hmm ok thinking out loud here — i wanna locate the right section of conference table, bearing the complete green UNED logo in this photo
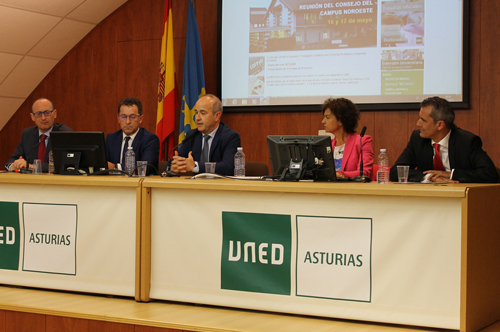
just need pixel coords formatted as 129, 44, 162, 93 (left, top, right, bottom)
140, 177, 500, 331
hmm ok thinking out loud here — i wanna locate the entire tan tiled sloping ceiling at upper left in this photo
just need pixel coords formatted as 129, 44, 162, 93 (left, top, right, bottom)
0, 0, 128, 130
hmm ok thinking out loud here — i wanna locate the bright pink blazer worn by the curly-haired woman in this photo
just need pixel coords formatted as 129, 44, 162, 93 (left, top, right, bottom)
332, 133, 373, 178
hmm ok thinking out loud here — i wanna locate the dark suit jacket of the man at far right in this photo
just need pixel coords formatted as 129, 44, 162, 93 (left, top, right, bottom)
391, 128, 498, 183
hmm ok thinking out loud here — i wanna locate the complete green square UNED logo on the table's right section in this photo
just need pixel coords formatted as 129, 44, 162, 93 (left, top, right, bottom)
221, 212, 292, 295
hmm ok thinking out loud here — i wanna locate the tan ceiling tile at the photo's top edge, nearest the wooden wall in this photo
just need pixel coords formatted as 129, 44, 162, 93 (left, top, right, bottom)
67, 0, 127, 24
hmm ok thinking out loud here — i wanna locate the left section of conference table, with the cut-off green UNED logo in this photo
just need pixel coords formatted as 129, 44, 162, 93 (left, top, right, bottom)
0, 173, 142, 300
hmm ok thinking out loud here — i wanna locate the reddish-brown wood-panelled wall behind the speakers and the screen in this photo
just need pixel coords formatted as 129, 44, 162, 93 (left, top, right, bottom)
0, 0, 500, 171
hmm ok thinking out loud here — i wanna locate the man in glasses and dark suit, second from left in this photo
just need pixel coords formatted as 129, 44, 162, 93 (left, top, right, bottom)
106, 97, 160, 174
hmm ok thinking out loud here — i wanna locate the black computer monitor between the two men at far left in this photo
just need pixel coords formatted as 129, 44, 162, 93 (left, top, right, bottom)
50, 131, 108, 174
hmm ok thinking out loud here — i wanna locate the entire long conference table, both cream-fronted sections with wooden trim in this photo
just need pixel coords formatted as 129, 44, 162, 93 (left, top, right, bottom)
0, 173, 500, 332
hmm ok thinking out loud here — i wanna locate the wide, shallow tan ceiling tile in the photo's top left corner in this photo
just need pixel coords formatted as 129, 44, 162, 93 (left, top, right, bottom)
0, 0, 84, 17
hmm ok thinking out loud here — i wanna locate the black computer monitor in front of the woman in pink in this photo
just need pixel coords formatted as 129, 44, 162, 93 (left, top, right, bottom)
267, 135, 336, 181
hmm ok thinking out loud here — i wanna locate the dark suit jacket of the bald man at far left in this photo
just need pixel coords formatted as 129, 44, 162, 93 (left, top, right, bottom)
5, 123, 73, 173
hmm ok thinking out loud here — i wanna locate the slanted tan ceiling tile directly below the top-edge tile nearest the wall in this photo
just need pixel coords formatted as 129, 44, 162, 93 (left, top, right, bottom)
28, 19, 95, 60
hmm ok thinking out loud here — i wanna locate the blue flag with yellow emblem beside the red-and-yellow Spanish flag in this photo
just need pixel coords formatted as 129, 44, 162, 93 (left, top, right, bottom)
179, 0, 206, 143
